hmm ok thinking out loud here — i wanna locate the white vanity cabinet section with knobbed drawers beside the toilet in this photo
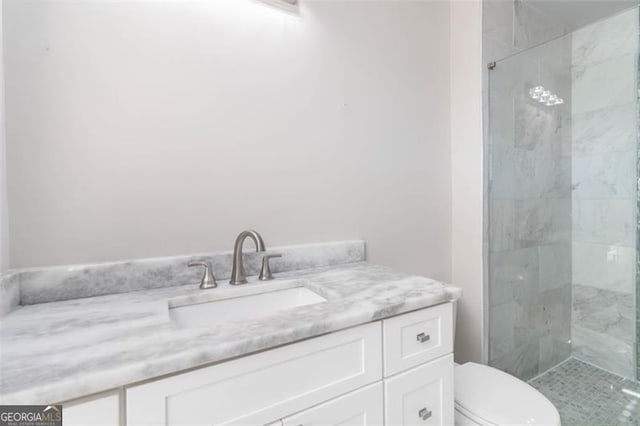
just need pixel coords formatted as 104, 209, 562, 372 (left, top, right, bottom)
125, 303, 454, 426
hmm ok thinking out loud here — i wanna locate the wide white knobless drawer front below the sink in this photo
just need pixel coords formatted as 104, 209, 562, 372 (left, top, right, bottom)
126, 323, 382, 426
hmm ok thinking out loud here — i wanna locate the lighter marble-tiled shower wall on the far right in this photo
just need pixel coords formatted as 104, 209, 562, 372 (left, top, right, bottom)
572, 8, 638, 377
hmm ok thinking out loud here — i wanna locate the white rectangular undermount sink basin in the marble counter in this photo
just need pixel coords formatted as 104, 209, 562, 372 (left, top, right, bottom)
169, 287, 327, 327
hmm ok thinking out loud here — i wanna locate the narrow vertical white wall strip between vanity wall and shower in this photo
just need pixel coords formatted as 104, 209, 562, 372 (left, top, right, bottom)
451, 0, 485, 362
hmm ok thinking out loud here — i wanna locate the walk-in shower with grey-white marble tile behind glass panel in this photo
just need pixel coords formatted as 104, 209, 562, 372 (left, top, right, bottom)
483, 0, 640, 424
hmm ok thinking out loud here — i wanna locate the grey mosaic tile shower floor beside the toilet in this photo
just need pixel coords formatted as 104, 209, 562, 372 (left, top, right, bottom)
529, 358, 640, 426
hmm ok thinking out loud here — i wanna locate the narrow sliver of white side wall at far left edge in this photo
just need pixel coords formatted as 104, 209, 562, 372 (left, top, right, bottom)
0, 2, 9, 273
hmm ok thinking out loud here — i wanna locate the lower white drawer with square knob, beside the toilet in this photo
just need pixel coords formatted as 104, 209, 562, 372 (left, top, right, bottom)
384, 355, 454, 425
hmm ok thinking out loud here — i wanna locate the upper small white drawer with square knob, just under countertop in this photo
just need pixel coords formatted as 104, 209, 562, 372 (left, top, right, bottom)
382, 303, 453, 376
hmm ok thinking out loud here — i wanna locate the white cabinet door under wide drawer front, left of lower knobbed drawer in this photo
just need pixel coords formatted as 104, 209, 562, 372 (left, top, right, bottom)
282, 382, 383, 426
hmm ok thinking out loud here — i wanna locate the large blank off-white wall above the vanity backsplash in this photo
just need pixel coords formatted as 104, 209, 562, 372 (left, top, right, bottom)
5, 0, 451, 280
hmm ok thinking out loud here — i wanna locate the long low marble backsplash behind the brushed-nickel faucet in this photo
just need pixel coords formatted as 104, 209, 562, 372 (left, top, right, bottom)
13, 241, 365, 305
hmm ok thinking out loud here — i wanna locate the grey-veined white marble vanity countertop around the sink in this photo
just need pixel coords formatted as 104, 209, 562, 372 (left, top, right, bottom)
0, 262, 461, 404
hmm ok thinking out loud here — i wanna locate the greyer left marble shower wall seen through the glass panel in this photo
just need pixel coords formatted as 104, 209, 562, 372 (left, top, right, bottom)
488, 31, 572, 379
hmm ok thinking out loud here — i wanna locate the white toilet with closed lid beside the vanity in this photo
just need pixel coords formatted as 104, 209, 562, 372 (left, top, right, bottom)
455, 362, 560, 425
